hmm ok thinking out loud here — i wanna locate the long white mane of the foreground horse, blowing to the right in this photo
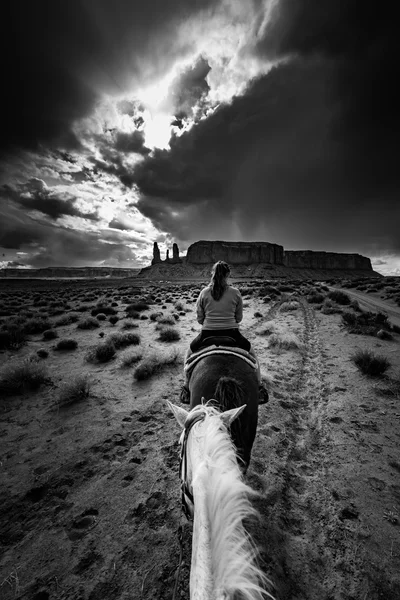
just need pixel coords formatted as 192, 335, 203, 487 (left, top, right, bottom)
189, 405, 273, 600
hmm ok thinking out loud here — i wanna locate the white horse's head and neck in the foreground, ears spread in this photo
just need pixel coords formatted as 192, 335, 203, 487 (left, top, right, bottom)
167, 401, 273, 600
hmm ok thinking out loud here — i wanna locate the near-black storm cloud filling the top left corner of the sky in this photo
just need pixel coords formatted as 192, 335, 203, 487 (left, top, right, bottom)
0, 0, 213, 157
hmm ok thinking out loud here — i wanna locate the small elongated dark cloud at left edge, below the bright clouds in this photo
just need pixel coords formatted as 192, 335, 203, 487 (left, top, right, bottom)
0, 178, 98, 221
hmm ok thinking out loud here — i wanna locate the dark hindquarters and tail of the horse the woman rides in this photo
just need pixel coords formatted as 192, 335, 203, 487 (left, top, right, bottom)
189, 354, 259, 472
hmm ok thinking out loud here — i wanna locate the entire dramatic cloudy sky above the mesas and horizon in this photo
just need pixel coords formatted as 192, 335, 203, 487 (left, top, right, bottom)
0, 0, 400, 275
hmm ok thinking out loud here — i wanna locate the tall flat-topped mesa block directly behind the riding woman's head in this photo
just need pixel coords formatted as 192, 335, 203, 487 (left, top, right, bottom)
186, 240, 284, 265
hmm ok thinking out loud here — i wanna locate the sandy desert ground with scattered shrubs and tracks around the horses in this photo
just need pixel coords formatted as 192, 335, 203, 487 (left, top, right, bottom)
0, 277, 400, 600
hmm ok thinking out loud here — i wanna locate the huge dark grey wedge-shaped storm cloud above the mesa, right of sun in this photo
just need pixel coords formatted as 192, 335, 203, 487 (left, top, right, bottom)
130, 55, 400, 252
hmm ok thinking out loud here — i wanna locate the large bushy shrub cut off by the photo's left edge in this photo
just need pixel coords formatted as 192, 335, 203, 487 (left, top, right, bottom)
0, 357, 48, 394
